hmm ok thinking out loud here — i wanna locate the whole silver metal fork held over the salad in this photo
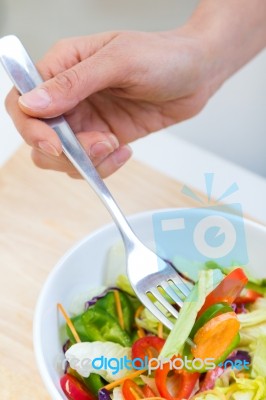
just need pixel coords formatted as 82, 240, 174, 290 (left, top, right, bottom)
0, 35, 190, 330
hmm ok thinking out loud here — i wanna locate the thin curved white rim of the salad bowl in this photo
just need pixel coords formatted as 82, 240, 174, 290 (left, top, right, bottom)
33, 206, 266, 400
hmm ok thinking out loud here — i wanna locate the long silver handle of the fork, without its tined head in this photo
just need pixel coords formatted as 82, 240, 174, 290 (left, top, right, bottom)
0, 35, 138, 246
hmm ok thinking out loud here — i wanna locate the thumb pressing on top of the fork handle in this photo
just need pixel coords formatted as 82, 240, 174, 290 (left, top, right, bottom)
19, 53, 121, 118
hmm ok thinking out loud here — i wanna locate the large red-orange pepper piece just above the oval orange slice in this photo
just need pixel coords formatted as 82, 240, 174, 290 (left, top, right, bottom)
198, 268, 248, 317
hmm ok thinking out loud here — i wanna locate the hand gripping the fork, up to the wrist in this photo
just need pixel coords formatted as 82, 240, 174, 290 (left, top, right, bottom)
6, 29, 213, 177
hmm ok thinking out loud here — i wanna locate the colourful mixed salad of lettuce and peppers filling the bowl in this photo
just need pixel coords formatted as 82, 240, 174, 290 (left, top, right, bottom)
58, 245, 266, 400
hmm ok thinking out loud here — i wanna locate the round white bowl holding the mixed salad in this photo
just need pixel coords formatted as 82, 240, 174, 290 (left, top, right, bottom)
34, 209, 266, 400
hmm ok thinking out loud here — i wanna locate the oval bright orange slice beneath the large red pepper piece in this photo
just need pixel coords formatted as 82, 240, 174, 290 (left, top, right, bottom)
191, 312, 240, 362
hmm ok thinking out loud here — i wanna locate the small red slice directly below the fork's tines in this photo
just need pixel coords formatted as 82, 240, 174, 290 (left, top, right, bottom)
132, 336, 165, 368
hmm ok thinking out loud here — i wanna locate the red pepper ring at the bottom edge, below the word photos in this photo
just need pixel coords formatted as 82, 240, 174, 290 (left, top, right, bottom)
155, 356, 200, 400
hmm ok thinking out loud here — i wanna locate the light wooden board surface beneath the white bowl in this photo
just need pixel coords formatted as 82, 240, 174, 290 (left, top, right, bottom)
0, 145, 206, 400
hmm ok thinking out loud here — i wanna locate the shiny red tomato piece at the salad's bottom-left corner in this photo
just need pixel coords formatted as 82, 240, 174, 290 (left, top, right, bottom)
60, 374, 96, 400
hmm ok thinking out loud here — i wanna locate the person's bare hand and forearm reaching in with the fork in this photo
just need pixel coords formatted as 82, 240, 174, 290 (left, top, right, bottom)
4, 0, 266, 176
